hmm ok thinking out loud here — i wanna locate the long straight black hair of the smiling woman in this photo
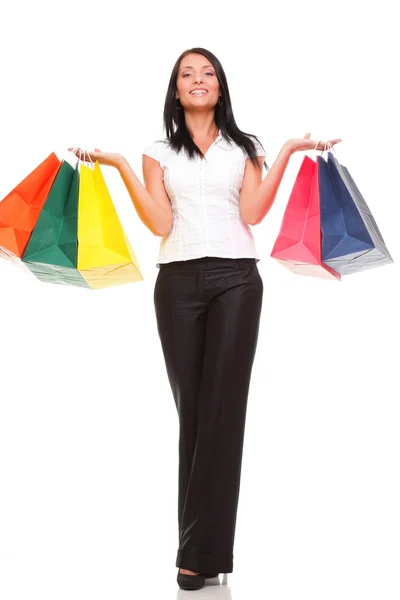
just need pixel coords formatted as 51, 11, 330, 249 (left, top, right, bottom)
163, 48, 269, 171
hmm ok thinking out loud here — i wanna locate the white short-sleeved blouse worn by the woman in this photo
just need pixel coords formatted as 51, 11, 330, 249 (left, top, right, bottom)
142, 130, 265, 267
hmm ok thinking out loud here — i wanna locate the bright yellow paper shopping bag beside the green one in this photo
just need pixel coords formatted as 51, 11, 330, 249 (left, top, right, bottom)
77, 161, 143, 290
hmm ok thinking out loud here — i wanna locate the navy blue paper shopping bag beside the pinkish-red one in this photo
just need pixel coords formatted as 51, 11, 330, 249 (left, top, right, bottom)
317, 152, 393, 275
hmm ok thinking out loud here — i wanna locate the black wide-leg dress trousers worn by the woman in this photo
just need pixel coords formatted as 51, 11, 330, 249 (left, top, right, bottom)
154, 257, 263, 573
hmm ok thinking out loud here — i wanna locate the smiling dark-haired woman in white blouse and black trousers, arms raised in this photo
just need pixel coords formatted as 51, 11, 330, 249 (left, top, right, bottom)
69, 48, 341, 590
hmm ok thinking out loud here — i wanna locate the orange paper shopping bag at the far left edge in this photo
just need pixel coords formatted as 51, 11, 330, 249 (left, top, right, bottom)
0, 152, 61, 262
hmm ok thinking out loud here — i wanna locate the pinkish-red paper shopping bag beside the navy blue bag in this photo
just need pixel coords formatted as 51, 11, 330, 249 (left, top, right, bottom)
271, 156, 341, 280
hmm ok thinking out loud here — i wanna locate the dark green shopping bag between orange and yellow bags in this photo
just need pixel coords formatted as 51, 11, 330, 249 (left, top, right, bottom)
22, 155, 89, 288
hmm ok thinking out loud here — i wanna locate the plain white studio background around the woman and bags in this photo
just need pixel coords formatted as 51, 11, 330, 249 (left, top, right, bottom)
0, 0, 400, 600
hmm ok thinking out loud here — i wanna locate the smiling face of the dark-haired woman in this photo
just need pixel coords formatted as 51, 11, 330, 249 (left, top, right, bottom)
176, 54, 219, 111
